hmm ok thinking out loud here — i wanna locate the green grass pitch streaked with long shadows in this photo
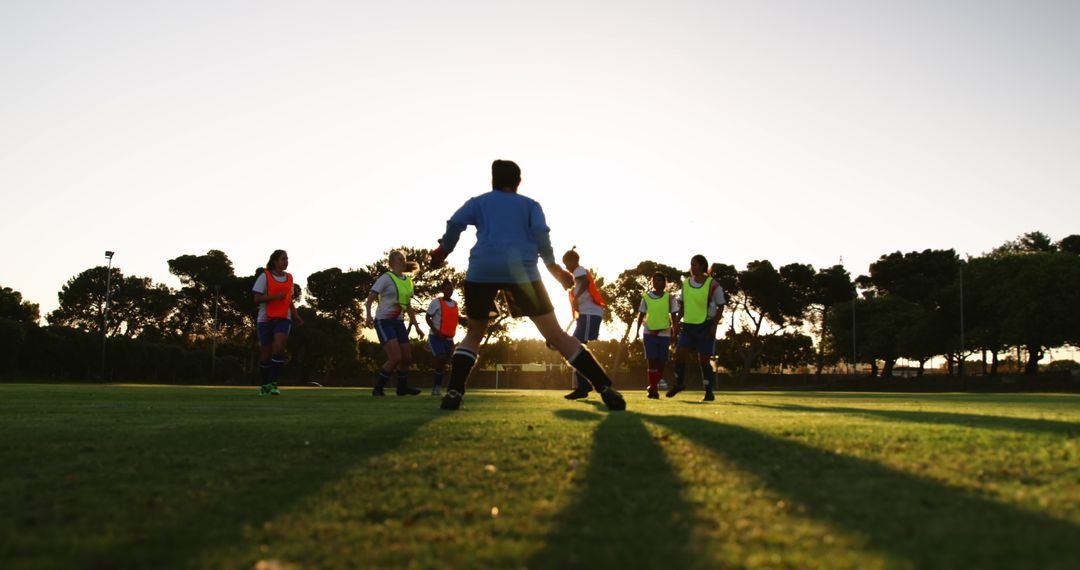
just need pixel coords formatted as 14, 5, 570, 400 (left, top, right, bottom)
0, 384, 1080, 569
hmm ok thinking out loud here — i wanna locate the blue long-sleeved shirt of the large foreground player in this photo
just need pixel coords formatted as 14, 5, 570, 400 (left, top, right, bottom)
438, 190, 555, 283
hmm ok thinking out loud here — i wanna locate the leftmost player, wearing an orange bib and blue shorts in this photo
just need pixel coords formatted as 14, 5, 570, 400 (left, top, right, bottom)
252, 249, 303, 396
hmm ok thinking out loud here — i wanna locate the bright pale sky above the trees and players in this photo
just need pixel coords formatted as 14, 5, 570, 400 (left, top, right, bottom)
0, 0, 1080, 334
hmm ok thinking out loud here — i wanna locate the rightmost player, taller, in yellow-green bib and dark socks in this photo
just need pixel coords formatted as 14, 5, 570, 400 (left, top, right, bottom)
667, 254, 727, 402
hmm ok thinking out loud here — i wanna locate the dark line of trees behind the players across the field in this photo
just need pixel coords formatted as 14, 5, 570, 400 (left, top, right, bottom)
0, 232, 1080, 383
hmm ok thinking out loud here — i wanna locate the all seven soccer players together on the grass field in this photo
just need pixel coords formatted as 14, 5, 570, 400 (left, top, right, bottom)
252, 160, 725, 410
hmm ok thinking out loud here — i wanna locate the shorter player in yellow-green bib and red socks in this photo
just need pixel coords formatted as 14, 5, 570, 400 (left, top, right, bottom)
634, 271, 679, 399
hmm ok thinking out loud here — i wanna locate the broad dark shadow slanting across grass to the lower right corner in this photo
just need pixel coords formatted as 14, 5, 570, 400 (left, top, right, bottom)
645, 416, 1080, 568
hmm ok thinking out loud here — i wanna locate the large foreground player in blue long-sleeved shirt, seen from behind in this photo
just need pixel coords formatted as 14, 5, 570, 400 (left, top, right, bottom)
431, 160, 626, 410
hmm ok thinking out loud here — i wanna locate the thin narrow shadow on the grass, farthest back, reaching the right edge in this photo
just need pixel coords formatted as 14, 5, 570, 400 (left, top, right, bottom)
744, 404, 1080, 437
